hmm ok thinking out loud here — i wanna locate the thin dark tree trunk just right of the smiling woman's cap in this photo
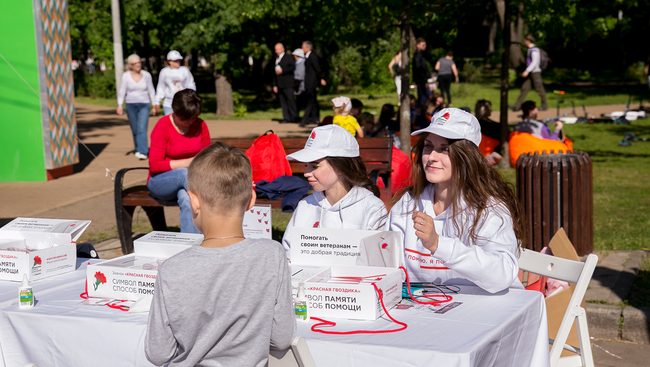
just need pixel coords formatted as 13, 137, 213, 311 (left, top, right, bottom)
497, 2, 511, 168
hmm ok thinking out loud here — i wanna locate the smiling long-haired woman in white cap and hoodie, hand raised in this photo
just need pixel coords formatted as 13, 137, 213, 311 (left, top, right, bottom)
385, 108, 526, 293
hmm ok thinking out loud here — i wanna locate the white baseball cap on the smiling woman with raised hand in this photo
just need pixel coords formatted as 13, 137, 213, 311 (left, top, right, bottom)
411, 108, 481, 147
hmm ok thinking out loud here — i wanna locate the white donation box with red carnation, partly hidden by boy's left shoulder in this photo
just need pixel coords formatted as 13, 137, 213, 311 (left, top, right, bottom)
86, 231, 203, 301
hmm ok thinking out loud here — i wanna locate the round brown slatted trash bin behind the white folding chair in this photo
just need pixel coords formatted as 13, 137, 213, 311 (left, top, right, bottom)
517, 151, 594, 256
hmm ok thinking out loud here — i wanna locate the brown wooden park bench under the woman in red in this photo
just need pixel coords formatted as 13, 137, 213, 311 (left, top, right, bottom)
115, 138, 393, 254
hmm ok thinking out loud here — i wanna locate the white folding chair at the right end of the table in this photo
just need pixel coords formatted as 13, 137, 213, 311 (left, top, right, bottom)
519, 249, 598, 367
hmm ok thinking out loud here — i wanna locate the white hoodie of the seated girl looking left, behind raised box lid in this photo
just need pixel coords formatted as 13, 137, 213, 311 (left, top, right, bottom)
282, 186, 387, 259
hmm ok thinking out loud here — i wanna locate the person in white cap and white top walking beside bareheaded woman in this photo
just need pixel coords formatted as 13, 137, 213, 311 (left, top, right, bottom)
156, 50, 196, 116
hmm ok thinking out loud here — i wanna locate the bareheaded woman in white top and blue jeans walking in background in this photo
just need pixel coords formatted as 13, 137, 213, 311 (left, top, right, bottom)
117, 54, 158, 160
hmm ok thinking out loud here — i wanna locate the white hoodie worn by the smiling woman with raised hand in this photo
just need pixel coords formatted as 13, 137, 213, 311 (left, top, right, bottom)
384, 184, 523, 293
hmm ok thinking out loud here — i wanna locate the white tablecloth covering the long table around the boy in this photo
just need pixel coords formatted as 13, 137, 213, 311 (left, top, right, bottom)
0, 271, 549, 367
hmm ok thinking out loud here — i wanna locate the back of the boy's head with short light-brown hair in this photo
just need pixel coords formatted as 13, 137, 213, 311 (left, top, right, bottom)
187, 141, 253, 215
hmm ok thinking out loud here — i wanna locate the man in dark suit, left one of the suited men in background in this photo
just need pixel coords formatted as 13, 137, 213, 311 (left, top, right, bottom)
273, 43, 298, 123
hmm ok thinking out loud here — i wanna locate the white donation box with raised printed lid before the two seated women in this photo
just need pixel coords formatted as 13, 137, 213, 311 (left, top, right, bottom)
291, 228, 402, 320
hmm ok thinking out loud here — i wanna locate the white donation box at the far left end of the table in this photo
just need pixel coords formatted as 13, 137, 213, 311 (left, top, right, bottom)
0, 218, 90, 281
